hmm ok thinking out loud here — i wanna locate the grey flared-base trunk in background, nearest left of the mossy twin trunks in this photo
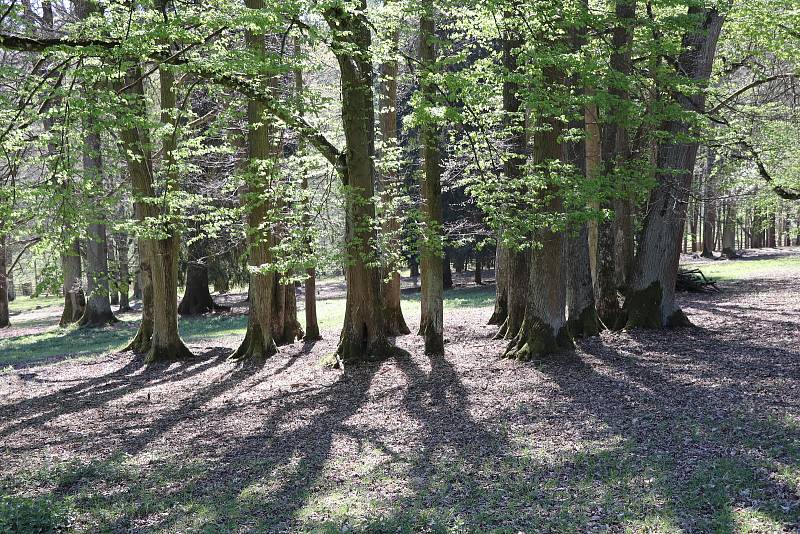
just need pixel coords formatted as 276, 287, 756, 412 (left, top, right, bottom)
78, 117, 117, 327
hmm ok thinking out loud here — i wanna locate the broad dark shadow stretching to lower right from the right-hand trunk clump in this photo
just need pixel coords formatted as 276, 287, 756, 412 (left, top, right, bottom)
540, 339, 800, 532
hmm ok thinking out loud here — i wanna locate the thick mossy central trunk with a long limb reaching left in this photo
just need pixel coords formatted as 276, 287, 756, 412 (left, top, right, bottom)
325, 0, 389, 365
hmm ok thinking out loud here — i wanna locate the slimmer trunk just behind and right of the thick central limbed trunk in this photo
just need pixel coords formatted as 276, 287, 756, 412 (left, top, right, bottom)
379, 6, 411, 336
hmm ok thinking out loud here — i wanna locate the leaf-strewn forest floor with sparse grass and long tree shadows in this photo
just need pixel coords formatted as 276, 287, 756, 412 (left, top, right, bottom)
0, 249, 800, 533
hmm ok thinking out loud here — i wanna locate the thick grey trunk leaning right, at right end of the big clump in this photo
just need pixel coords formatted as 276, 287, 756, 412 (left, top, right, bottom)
625, 6, 723, 328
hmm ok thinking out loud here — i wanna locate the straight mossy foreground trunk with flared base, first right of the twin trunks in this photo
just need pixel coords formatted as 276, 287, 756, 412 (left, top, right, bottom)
232, 0, 278, 361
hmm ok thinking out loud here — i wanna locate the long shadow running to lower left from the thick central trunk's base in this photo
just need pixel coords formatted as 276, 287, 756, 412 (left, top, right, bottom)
134, 354, 380, 532
